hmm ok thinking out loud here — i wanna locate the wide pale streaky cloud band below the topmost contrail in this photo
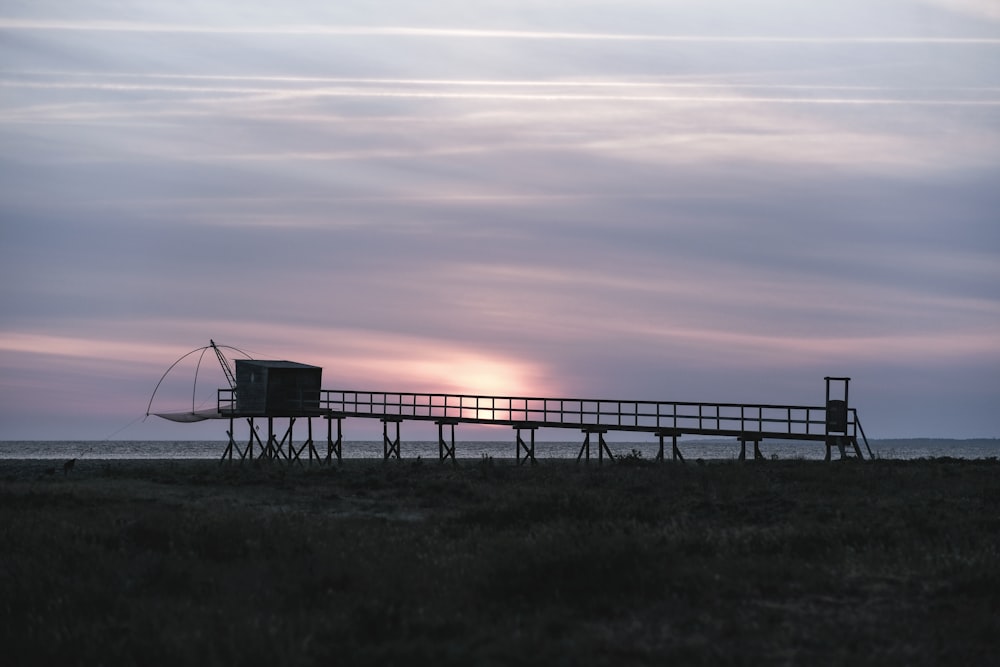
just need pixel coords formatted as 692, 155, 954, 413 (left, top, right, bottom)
0, 69, 1000, 181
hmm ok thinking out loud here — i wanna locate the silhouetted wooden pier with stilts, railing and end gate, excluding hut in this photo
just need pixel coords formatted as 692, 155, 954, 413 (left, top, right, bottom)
205, 377, 871, 464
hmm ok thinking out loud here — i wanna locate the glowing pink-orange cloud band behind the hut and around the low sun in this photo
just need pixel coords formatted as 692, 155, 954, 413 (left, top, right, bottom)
0, 320, 558, 411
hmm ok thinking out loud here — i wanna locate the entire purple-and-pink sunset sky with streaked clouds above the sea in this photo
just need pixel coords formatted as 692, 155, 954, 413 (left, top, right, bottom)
0, 0, 1000, 440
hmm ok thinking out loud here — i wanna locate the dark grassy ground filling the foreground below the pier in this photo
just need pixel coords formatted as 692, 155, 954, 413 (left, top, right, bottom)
0, 459, 1000, 667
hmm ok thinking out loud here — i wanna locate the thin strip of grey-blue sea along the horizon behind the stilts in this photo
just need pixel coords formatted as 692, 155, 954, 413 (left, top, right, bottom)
0, 437, 1000, 460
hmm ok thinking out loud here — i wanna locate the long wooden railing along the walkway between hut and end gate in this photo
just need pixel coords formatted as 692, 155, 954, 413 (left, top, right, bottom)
308, 390, 856, 439
